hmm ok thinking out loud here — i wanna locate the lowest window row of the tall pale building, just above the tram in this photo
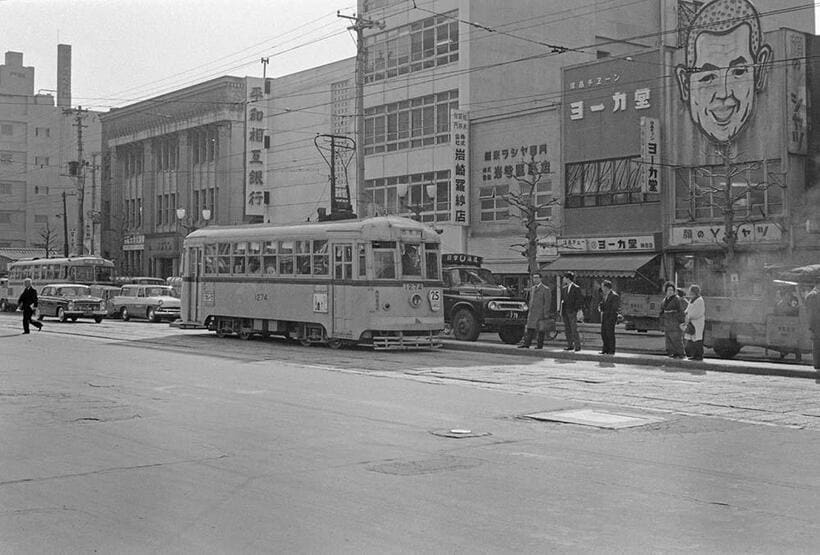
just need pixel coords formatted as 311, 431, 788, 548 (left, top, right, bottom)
365, 170, 450, 222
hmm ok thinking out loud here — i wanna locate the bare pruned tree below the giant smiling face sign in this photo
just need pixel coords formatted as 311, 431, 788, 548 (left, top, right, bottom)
692, 144, 785, 270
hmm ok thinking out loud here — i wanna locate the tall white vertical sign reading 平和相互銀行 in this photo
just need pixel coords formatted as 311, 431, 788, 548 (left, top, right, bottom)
245, 77, 267, 216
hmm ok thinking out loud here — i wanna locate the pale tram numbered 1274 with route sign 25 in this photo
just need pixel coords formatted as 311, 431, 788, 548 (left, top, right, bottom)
180, 216, 444, 349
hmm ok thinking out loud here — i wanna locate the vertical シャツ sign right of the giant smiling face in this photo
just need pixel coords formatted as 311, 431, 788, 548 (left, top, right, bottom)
786, 31, 808, 154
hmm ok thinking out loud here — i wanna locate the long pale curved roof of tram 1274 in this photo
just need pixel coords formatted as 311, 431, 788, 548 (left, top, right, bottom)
186, 216, 438, 241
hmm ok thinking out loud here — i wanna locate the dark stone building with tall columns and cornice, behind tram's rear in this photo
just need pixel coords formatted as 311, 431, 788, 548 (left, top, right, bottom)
101, 77, 247, 277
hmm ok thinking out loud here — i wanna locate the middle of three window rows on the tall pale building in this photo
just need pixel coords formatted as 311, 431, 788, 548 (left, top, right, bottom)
364, 90, 458, 154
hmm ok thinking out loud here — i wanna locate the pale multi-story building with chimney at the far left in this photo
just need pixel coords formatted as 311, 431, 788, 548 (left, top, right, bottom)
0, 45, 101, 254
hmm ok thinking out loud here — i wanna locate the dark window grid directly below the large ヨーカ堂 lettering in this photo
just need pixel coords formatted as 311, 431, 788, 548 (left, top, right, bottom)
565, 157, 660, 208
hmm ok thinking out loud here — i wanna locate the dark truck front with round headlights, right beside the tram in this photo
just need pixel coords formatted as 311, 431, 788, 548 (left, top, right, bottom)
441, 254, 527, 344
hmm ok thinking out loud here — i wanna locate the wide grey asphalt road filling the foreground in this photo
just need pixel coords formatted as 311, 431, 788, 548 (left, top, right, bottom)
0, 315, 820, 553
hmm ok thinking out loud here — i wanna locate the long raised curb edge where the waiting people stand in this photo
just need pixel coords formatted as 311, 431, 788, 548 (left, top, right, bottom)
442, 339, 820, 381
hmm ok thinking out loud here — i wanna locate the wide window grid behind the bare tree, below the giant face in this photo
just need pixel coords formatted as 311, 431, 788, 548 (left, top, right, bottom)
675, 160, 786, 222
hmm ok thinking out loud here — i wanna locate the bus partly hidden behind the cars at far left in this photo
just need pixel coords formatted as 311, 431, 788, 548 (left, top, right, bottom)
3, 256, 114, 310
